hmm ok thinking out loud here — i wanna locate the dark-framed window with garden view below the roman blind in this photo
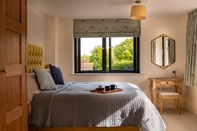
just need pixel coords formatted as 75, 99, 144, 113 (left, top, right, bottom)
74, 37, 139, 73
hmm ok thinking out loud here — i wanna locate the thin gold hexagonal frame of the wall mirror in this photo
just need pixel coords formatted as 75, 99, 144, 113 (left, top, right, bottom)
151, 34, 176, 69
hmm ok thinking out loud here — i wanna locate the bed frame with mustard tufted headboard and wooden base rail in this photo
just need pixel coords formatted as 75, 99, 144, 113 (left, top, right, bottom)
27, 44, 140, 131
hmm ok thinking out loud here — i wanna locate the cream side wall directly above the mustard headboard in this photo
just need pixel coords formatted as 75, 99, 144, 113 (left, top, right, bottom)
27, 5, 45, 67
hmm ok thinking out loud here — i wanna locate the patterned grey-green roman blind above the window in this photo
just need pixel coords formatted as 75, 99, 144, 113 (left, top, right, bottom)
73, 19, 141, 38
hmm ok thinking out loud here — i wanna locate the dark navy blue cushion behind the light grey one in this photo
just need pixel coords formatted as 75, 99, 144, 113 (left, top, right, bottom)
49, 64, 64, 84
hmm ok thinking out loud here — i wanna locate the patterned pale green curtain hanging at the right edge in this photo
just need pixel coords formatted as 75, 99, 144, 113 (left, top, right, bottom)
184, 9, 197, 87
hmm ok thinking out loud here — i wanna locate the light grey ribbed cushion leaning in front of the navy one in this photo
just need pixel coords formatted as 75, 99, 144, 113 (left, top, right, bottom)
33, 69, 57, 90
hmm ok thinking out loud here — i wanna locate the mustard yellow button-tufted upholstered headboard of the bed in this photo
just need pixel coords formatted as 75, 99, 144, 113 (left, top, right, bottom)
27, 44, 43, 73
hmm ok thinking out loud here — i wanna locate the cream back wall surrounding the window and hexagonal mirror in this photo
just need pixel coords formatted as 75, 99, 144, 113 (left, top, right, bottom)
28, 5, 189, 109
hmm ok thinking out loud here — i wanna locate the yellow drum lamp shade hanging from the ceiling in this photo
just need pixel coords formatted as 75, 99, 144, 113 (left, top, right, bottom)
130, 5, 146, 20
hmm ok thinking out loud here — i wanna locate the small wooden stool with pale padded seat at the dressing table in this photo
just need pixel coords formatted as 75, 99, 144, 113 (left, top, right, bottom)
157, 86, 182, 115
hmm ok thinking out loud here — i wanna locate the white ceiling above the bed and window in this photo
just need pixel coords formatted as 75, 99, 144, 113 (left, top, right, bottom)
27, 0, 197, 19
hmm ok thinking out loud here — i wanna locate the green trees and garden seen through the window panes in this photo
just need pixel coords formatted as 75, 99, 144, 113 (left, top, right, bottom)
81, 38, 134, 70
